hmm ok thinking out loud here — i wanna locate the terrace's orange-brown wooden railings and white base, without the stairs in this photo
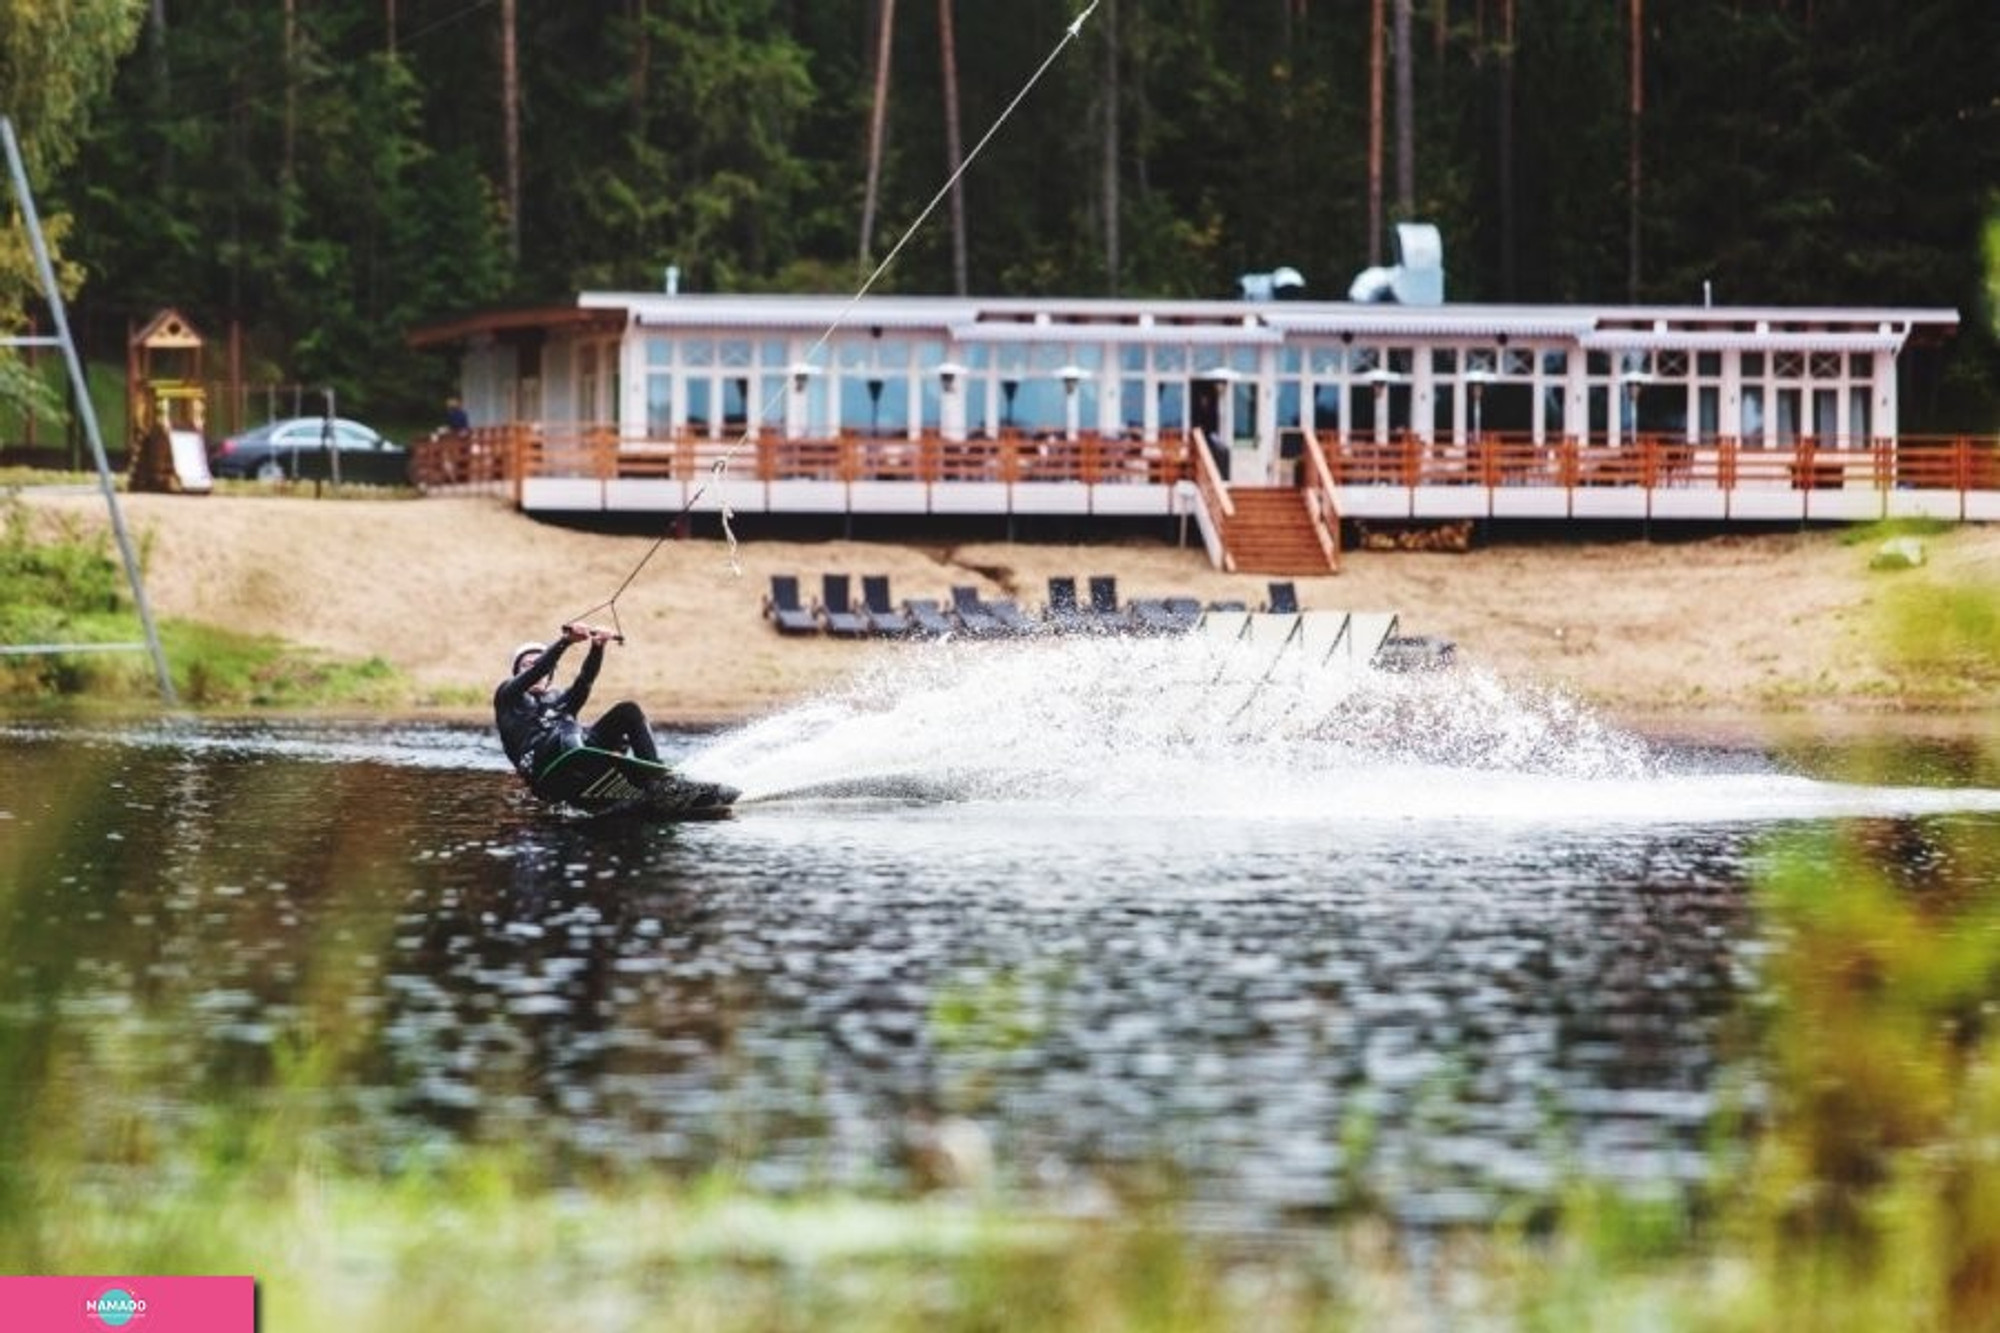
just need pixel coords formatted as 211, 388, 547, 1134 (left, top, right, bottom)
412, 424, 2000, 522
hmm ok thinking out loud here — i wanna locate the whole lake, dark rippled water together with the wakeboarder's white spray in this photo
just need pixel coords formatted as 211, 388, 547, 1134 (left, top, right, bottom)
0, 640, 2000, 1231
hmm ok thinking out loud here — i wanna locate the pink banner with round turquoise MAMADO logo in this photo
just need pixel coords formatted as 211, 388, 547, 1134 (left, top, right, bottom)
0, 1277, 256, 1333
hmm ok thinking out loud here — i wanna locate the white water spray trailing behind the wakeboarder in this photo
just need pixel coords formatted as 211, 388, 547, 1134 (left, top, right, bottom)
682, 638, 2000, 823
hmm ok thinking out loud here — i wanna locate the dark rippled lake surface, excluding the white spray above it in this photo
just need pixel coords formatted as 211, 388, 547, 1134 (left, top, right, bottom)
0, 727, 1990, 1227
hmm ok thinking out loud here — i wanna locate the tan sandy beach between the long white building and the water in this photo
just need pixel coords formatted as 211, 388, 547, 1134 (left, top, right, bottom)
19, 490, 2000, 723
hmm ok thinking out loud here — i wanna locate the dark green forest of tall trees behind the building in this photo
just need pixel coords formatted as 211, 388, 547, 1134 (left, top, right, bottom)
0, 0, 2000, 432
